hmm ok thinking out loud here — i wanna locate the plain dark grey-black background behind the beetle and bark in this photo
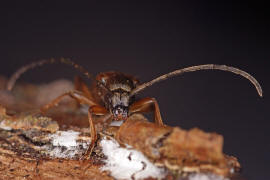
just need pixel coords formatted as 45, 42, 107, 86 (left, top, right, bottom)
0, 1, 270, 179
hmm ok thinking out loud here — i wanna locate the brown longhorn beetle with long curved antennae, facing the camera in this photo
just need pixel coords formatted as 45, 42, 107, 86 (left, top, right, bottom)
7, 58, 262, 157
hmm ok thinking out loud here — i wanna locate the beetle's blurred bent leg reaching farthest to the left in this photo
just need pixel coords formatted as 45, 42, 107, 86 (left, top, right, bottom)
40, 91, 97, 113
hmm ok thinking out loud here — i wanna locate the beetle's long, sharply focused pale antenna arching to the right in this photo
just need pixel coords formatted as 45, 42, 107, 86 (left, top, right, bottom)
130, 64, 263, 97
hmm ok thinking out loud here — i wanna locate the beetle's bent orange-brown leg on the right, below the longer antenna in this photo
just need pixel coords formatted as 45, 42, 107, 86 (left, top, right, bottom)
129, 97, 163, 126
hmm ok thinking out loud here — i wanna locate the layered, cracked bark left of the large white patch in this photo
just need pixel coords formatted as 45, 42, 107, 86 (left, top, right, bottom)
0, 108, 113, 180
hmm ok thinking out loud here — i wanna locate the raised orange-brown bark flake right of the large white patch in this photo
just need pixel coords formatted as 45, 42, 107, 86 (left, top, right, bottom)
116, 114, 240, 176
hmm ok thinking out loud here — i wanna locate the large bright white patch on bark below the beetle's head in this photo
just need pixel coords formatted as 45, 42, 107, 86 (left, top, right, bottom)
100, 139, 166, 179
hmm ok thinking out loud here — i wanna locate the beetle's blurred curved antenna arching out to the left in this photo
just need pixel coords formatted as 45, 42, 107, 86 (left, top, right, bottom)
7, 58, 95, 91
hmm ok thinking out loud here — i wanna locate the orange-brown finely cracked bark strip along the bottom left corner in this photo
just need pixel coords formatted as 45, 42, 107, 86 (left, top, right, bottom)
0, 152, 113, 180
